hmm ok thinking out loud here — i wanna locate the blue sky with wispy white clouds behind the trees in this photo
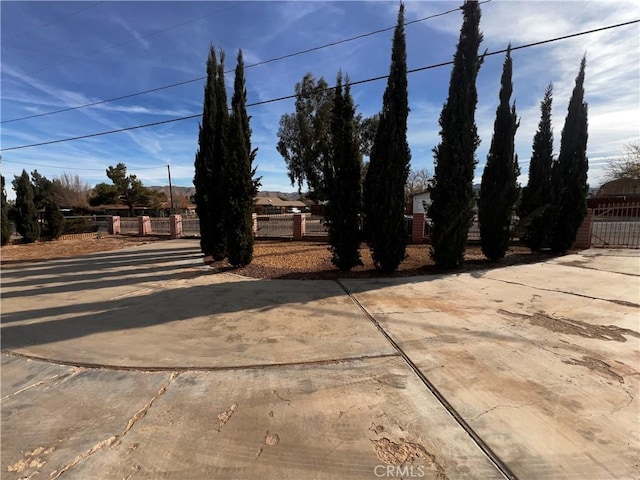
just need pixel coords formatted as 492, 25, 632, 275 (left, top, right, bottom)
0, 0, 640, 199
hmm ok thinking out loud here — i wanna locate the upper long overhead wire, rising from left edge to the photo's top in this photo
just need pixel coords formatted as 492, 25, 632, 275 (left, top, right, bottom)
0, 0, 484, 124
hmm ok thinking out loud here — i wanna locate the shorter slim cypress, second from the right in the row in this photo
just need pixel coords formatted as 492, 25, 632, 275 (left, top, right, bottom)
518, 83, 553, 252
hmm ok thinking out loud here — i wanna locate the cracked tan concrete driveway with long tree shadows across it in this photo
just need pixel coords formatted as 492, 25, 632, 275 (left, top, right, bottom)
0, 240, 640, 480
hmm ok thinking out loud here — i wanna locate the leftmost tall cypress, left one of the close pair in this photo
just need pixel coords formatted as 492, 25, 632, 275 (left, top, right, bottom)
193, 46, 219, 256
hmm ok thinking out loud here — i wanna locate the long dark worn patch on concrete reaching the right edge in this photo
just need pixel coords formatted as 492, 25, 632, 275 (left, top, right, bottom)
498, 309, 640, 342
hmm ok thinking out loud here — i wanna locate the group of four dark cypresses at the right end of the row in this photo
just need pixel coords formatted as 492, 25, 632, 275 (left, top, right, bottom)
429, 1, 588, 268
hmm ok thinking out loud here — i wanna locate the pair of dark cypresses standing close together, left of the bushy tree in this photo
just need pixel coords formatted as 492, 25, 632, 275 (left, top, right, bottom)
193, 46, 259, 266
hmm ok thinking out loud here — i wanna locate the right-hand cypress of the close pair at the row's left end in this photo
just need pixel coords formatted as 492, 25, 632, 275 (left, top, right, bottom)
226, 50, 257, 266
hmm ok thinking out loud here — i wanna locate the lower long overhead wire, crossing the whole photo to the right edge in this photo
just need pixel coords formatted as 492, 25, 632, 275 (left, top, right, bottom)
0, 19, 640, 152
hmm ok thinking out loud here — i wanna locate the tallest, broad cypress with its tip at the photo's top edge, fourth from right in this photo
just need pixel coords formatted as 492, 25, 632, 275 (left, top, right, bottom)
429, 0, 484, 268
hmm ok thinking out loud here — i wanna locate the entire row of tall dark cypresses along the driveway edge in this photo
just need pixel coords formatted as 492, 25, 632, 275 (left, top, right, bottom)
194, 0, 588, 272
